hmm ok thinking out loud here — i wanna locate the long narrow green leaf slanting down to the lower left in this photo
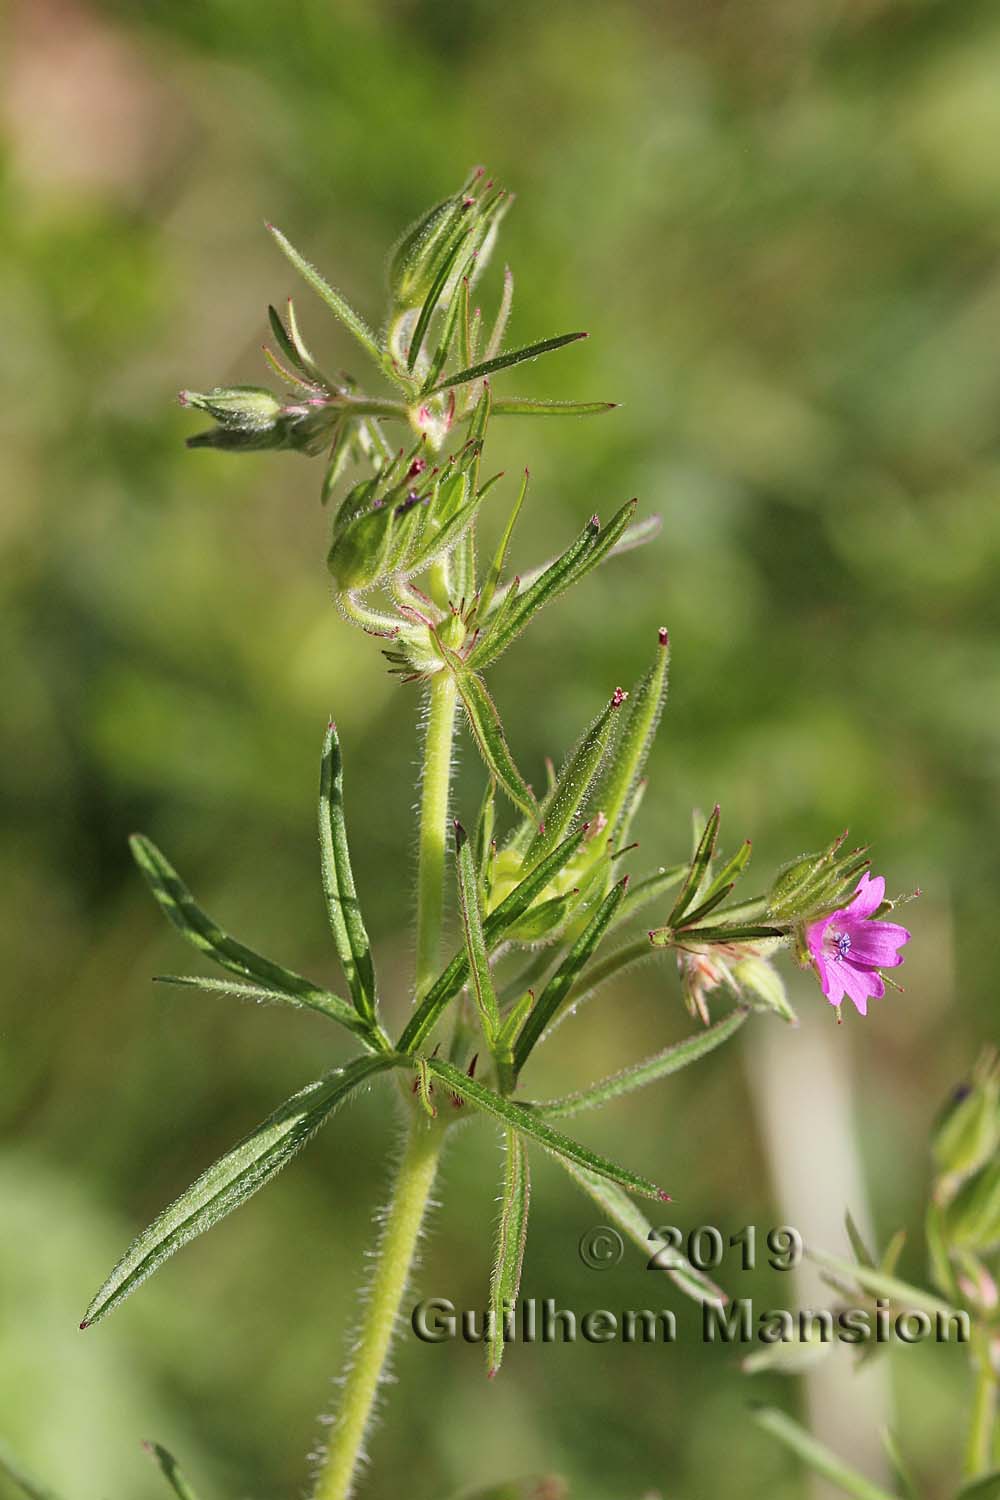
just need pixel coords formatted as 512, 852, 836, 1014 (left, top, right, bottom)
81, 1056, 399, 1328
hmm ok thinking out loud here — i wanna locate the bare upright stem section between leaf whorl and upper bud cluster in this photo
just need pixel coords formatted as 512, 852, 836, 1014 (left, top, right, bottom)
417, 671, 459, 999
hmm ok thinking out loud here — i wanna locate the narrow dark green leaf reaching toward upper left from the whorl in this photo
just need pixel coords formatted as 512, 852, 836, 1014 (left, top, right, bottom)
129, 834, 370, 1044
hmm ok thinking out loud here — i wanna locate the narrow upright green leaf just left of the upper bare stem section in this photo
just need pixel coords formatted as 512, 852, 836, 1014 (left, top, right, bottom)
319, 720, 376, 1023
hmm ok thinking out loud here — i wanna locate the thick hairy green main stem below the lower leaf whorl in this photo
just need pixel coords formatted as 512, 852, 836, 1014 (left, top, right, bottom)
313, 1109, 444, 1500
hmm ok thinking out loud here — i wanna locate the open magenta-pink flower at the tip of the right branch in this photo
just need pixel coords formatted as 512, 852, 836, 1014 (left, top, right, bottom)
805, 870, 910, 1016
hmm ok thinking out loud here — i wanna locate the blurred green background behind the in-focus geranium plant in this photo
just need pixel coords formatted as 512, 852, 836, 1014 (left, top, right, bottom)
0, 0, 1000, 1500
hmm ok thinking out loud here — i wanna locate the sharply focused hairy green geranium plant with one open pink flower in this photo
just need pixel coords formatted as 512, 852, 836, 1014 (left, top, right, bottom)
1, 171, 903, 1500
